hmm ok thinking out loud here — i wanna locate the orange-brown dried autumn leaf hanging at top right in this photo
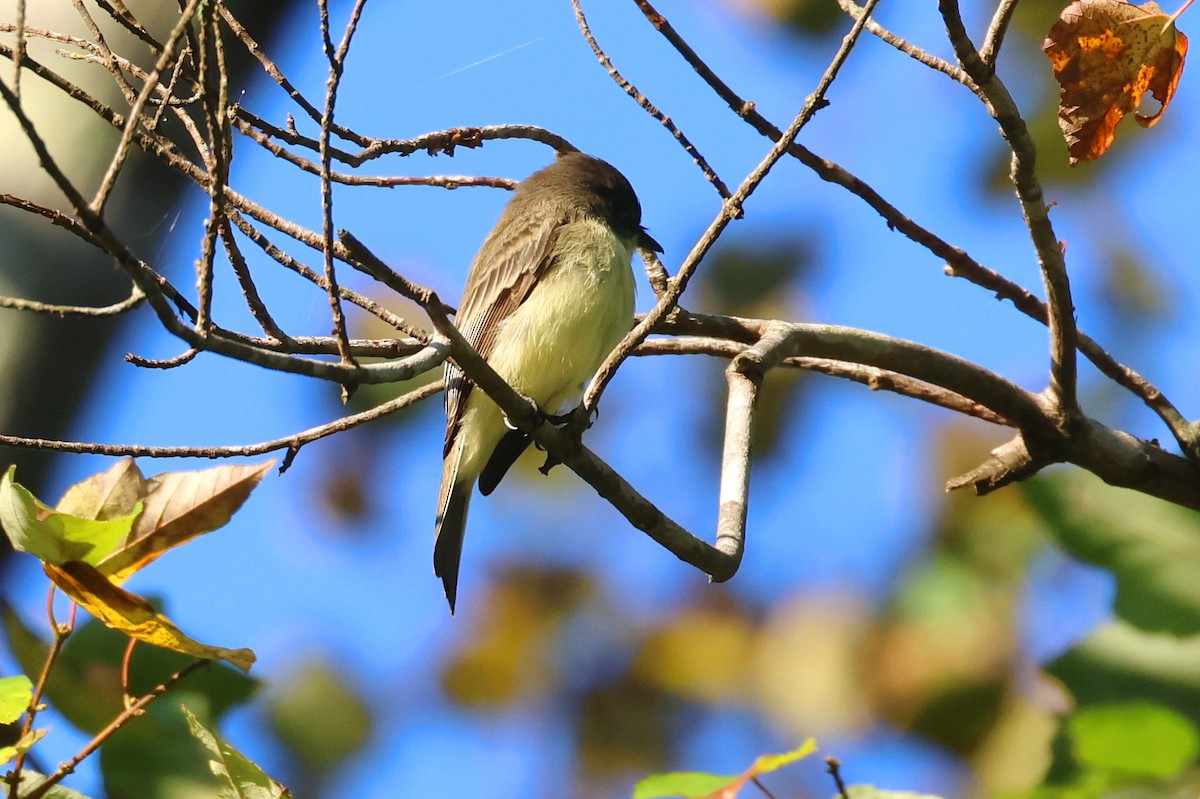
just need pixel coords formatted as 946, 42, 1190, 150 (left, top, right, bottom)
1042, 0, 1188, 166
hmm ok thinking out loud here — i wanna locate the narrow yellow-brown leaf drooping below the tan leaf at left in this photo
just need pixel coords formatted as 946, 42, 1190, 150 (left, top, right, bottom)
43, 560, 254, 669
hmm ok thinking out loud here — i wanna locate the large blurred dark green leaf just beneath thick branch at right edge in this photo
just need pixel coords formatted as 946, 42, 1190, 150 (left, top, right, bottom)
1021, 473, 1200, 636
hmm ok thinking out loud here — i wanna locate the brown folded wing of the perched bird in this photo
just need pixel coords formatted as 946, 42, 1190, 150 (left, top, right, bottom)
443, 208, 562, 457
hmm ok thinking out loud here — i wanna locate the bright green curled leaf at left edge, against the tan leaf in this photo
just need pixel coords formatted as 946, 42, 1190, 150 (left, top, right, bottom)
0, 465, 142, 565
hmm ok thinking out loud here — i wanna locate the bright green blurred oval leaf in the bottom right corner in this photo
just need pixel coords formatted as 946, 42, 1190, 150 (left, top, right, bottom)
1067, 702, 1200, 777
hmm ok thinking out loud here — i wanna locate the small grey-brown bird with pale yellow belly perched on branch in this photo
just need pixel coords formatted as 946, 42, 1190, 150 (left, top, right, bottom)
433, 152, 662, 613
